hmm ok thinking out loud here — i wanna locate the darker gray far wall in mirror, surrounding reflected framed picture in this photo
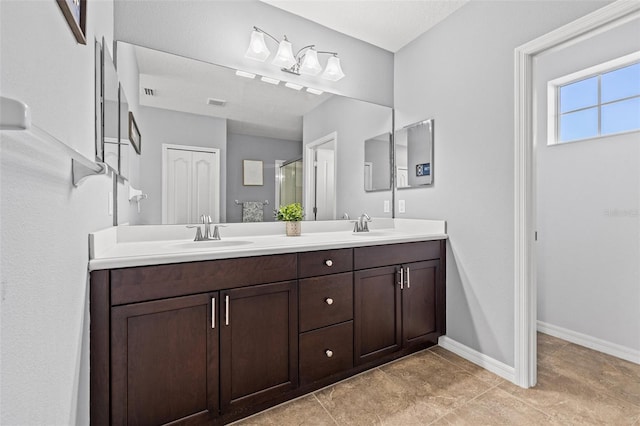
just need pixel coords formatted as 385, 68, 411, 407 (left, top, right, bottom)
227, 133, 302, 222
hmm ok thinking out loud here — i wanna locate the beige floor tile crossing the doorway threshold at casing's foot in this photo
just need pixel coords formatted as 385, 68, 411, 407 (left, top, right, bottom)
499, 366, 640, 425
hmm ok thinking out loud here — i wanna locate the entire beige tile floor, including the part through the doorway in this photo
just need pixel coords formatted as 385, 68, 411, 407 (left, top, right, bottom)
236, 334, 640, 426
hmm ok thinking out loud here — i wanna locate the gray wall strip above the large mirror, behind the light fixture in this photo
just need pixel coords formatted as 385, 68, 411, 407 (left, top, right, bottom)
114, 0, 393, 106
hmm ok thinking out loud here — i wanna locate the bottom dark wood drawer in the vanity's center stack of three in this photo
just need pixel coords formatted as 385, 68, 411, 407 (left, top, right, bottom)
300, 321, 353, 385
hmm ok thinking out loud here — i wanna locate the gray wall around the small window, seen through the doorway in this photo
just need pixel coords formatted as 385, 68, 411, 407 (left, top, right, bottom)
535, 19, 640, 352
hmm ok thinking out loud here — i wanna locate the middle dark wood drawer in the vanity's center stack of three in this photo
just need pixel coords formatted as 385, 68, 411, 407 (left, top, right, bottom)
298, 272, 353, 332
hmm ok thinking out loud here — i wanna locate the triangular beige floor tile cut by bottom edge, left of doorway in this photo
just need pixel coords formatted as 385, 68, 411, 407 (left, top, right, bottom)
434, 388, 560, 426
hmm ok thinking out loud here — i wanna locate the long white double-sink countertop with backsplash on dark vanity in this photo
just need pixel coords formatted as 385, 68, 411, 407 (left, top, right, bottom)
89, 218, 447, 271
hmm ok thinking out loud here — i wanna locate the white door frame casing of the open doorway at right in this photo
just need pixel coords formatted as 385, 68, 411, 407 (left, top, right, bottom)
514, 0, 640, 388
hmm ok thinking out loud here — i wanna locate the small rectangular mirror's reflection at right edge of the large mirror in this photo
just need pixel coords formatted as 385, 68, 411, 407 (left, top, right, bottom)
364, 132, 391, 192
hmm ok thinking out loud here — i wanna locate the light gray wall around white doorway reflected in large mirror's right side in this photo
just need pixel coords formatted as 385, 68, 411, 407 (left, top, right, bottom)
302, 96, 391, 219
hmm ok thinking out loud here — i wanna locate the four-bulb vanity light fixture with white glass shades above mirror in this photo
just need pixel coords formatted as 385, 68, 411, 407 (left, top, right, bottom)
244, 27, 344, 81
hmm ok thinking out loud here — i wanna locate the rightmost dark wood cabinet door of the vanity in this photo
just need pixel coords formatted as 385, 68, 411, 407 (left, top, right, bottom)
402, 260, 440, 347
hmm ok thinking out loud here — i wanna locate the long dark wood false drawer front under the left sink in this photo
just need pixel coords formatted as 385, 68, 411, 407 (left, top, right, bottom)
111, 254, 296, 306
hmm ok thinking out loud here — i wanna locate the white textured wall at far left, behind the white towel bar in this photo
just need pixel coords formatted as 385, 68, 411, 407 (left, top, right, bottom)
0, 1, 113, 425
